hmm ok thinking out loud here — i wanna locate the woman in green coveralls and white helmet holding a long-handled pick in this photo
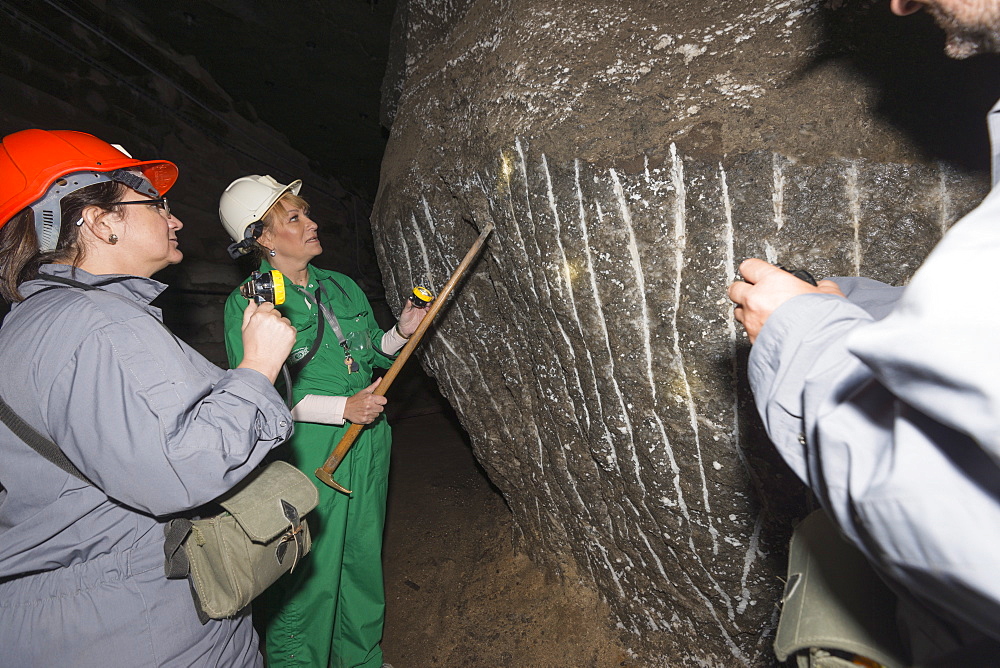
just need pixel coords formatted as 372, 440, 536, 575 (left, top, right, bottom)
219, 176, 426, 668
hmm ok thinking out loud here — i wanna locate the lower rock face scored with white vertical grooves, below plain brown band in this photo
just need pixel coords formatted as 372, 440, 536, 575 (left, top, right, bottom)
376, 141, 981, 661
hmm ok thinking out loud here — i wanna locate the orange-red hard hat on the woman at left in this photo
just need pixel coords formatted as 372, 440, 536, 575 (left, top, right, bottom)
0, 130, 177, 227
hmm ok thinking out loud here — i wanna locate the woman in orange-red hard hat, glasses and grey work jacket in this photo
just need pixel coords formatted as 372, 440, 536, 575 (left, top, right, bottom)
0, 130, 295, 668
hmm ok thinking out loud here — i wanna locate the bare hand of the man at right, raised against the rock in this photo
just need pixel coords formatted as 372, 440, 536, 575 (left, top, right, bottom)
729, 258, 844, 343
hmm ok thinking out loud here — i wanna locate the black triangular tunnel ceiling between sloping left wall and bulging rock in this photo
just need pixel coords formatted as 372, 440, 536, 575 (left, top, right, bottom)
121, 0, 396, 199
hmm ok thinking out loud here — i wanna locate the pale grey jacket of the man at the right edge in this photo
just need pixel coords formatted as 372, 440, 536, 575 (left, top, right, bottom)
749, 98, 1000, 665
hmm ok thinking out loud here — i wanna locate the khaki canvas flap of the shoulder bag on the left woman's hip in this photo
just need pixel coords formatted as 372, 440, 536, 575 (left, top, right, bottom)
216, 461, 319, 543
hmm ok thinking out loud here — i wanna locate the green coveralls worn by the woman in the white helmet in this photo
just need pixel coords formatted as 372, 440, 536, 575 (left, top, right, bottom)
225, 261, 393, 668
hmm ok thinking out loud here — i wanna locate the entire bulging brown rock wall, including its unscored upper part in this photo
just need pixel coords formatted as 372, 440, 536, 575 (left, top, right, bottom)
372, 0, 997, 666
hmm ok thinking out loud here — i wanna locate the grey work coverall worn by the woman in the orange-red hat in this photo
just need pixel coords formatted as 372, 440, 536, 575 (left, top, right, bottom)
0, 265, 292, 668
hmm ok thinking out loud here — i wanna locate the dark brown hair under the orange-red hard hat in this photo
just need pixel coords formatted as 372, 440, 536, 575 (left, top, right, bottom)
0, 181, 127, 302
